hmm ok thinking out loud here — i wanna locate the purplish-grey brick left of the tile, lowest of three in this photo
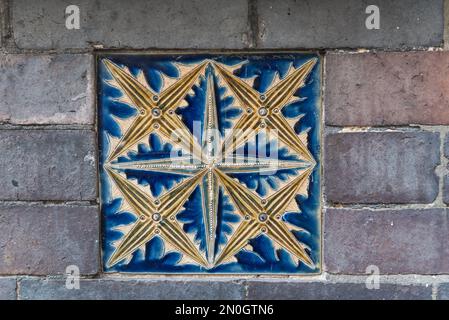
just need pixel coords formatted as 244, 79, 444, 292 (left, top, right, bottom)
0, 204, 100, 275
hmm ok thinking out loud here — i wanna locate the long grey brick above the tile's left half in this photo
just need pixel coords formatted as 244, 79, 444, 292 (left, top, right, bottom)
12, 0, 248, 49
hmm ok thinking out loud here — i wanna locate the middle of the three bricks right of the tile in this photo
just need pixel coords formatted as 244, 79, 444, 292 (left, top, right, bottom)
324, 132, 439, 203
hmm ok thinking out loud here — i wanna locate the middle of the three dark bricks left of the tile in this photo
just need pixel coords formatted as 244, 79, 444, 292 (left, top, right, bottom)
0, 130, 97, 200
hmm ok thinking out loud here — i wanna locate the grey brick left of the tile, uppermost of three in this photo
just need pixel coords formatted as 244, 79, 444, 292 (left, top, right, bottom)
0, 54, 94, 124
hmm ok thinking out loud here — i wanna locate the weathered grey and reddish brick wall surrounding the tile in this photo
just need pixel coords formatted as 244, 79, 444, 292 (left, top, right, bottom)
0, 0, 449, 299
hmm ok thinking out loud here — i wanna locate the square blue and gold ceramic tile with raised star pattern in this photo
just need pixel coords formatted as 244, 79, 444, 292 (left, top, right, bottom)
98, 54, 321, 274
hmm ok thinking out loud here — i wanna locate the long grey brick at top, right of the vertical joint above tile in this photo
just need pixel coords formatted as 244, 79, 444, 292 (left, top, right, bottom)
258, 0, 443, 49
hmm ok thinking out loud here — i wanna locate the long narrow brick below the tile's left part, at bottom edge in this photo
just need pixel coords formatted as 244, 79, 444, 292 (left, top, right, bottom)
19, 279, 244, 300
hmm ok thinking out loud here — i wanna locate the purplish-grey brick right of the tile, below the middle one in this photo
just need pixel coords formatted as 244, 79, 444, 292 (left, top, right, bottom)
324, 209, 449, 274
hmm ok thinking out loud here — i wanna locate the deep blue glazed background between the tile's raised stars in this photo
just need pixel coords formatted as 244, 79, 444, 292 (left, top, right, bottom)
98, 54, 321, 273
